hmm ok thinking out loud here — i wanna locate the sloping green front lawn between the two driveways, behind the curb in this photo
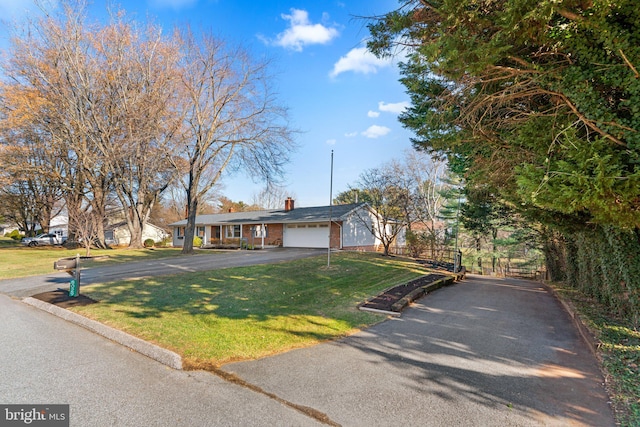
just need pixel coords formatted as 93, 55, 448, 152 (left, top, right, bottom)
73, 253, 440, 369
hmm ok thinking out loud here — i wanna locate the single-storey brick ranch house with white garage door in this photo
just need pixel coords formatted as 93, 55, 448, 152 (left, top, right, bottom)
170, 198, 404, 251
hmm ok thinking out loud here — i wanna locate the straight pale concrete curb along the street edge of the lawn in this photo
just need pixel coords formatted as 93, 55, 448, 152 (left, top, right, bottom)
22, 297, 182, 370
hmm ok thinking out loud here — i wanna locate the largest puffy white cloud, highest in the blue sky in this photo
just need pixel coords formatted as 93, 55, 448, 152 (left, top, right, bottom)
275, 9, 339, 52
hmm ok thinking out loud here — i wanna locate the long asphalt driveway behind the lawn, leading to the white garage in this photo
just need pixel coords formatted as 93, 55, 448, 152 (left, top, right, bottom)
0, 248, 326, 298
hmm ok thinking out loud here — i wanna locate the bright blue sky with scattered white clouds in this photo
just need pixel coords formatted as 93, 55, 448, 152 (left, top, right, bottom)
0, 0, 411, 207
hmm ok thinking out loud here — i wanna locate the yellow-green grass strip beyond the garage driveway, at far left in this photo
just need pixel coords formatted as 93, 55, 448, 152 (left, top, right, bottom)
0, 237, 188, 280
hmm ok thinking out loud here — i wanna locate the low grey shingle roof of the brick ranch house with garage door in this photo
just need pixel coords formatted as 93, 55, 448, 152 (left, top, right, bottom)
169, 203, 365, 227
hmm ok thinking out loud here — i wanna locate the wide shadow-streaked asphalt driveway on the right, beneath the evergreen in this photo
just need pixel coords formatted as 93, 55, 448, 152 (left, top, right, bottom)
223, 276, 615, 427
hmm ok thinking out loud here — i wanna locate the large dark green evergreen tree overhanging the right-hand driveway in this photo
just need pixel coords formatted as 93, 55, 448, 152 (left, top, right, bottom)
369, 0, 640, 228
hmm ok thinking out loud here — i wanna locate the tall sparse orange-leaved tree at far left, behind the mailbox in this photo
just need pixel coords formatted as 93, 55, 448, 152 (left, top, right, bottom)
3, 1, 110, 244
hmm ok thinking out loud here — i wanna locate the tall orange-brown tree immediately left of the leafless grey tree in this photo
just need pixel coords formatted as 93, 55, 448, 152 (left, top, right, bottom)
85, 13, 180, 247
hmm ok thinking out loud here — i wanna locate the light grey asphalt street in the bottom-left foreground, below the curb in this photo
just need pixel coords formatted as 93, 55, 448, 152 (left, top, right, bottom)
0, 295, 321, 427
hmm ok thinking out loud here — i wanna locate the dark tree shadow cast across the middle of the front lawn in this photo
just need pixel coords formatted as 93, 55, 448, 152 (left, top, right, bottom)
85, 266, 382, 326
